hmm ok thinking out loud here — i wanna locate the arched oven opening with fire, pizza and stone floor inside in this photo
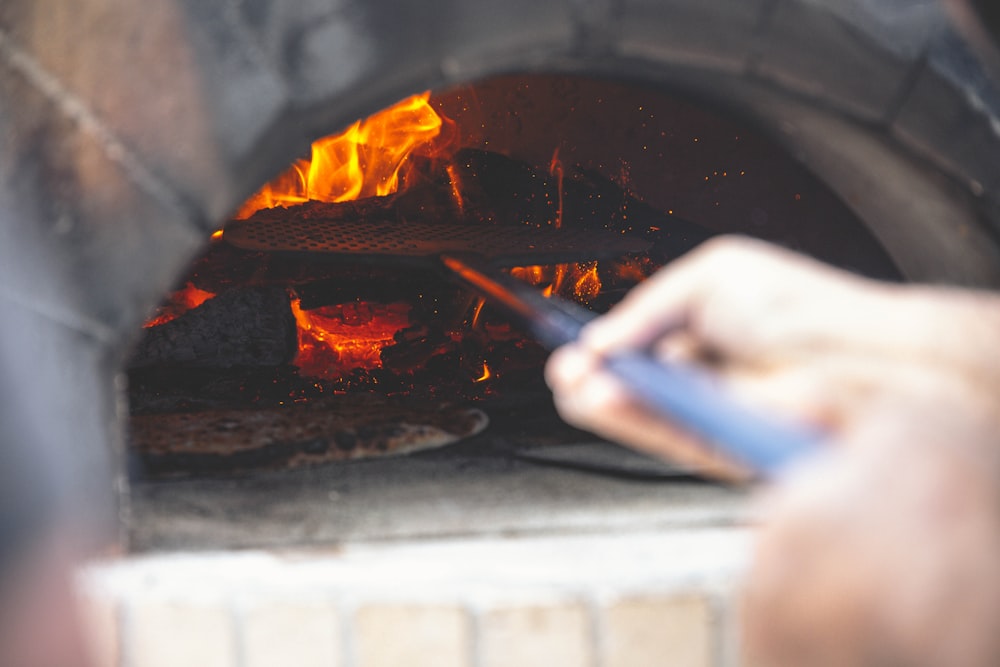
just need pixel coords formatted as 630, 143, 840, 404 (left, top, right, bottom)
128, 74, 900, 549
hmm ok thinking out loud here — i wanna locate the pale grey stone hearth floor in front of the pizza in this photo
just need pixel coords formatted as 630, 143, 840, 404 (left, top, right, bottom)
128, 434, 749, 551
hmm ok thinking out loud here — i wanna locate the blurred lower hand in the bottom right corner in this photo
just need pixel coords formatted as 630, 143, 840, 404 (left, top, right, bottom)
741, 404, 1000, 667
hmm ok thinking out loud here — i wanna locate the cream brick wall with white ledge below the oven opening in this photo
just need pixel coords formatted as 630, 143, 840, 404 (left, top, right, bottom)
80, 529, 747, 667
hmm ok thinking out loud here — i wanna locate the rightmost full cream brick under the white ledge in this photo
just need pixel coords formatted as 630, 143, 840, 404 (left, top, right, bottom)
601, 595, 715, 667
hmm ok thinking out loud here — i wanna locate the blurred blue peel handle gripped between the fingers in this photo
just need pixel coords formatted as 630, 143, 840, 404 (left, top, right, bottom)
606, 353, 824, 477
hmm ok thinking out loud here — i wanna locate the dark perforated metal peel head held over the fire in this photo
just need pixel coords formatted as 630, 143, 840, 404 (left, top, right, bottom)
224, 216, 650, 266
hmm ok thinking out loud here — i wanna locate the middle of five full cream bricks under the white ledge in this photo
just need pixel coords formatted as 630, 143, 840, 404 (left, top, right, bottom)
355, 605, 471, 667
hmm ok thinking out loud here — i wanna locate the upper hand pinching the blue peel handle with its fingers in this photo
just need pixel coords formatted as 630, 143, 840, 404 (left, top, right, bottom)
547, 238, 1000, 478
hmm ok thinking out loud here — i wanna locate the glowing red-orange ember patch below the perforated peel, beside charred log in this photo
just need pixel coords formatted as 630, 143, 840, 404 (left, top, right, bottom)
292, 299, 410, 379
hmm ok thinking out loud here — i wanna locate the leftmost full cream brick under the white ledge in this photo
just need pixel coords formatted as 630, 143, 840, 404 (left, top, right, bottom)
125, 601, 236, 667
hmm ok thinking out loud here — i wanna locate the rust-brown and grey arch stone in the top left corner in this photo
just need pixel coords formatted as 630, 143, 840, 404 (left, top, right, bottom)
0, 0, 286, 221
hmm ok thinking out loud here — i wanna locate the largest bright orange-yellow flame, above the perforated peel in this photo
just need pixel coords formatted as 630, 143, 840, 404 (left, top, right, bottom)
236, 91, 444, 219
